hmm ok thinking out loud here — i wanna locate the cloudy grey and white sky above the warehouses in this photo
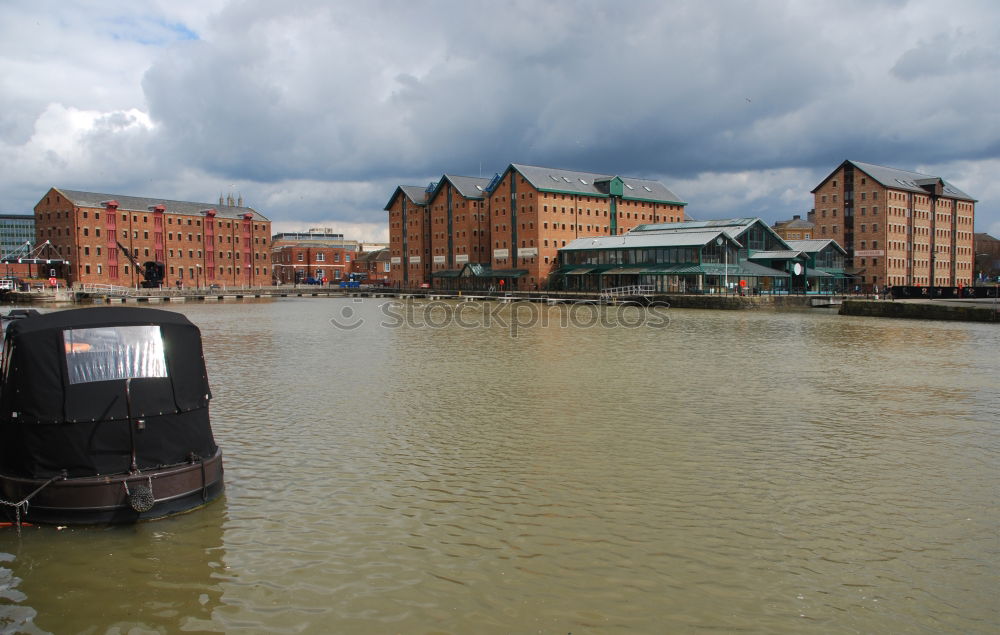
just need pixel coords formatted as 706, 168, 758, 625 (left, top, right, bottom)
0, 0, 1000, 240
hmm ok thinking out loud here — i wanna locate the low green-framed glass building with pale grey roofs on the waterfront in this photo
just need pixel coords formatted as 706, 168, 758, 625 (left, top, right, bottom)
549, 217, 843, 293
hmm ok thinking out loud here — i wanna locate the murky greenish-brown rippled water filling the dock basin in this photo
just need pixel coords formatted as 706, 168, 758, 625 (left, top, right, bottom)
0, 299, 1000, 634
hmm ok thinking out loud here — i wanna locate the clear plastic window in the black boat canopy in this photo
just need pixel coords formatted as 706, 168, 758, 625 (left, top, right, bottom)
63, 326, 167, 384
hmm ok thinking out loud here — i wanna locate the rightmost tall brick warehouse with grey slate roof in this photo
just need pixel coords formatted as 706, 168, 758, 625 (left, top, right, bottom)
809, 160, 976, 289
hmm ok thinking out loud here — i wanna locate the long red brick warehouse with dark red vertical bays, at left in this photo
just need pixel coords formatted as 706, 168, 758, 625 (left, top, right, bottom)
35, 188, 271, 286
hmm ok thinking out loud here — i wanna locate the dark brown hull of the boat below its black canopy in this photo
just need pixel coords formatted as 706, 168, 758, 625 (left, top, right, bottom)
0, 450, 225, 525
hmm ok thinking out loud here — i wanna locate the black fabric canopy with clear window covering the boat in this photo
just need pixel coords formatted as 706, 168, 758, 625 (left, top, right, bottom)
0, 307, 216, 478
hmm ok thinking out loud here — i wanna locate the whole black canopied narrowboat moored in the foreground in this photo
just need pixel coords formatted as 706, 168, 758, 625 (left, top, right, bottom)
0, 307, 224, 525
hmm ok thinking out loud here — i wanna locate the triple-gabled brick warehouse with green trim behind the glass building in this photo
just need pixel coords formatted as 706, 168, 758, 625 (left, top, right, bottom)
385, 163, 687, 290
